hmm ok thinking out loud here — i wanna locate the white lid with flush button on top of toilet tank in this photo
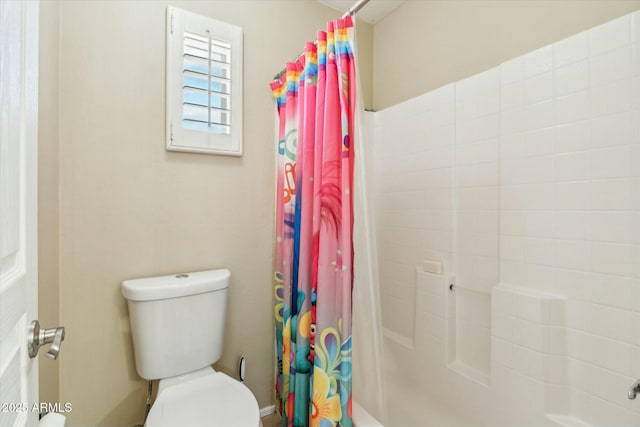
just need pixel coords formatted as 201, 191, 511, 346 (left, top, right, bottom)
122, 268, 231, 301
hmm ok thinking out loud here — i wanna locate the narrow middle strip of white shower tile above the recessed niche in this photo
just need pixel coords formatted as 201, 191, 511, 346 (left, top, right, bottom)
454, 69, 500, 298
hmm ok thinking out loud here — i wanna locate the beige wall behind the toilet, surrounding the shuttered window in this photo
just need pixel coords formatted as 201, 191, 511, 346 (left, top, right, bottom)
39, 0, 373, 427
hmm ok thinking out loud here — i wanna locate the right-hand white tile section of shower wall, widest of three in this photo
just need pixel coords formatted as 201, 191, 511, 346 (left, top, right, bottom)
494, 14, 640, 425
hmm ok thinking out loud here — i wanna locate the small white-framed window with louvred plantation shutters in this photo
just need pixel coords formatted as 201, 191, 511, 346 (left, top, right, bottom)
166, 7, 242, 156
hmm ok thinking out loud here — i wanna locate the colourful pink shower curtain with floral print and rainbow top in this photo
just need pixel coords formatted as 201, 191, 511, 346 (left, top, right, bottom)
271, 17, 356, 427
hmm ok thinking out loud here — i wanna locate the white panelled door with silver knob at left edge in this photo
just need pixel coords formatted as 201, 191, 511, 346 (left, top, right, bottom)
0, 0, 39, 427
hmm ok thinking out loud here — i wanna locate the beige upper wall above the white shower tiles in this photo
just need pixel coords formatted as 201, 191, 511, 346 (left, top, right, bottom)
373, 0, 640, 110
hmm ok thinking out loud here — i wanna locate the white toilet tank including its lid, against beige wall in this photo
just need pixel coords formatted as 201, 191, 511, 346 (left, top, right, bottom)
122, 269, 231, 380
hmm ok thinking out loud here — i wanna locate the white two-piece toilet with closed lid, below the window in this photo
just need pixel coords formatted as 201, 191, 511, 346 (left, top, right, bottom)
122, 269, 261, 427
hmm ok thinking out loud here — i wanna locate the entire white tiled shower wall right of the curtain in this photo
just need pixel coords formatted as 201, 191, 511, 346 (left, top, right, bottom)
373, 12, 640, 425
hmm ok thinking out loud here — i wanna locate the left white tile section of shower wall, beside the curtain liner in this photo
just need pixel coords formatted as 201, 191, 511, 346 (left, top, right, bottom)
373, 85, 455, 341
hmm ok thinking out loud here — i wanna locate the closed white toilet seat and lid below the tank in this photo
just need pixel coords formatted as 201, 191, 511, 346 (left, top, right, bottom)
145, 368, 260, 427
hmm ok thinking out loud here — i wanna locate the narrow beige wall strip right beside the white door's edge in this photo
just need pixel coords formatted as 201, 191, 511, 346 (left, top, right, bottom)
38, 2, 60, 410
